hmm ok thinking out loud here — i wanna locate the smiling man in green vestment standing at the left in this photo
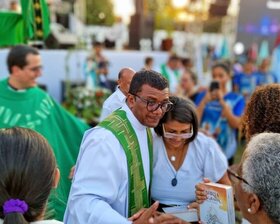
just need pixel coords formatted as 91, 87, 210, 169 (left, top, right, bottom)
0, 45, 89, 220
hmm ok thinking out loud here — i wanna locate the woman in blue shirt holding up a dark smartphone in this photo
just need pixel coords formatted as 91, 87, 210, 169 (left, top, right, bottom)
195, 63, 245, 165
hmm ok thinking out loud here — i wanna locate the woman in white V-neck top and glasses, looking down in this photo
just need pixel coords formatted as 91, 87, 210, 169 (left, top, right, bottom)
151, 96, 230, 212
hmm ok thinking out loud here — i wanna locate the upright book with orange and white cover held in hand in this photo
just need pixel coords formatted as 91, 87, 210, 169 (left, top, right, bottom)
200, 183, 235, 224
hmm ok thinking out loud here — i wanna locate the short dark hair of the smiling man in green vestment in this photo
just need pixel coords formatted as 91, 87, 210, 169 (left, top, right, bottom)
7, 45, 39, 73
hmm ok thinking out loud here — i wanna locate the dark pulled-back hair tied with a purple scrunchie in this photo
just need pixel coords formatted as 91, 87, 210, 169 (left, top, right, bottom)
0, 127, 56, 224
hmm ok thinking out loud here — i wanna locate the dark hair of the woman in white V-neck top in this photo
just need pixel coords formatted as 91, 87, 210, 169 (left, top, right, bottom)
154, 96, 198, 142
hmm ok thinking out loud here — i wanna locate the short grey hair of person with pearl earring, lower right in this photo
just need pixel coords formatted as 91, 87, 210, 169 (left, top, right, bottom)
241, 133, 280, 223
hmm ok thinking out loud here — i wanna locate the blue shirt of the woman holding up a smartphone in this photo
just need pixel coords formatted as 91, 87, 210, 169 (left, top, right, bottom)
195, 92, 245, 159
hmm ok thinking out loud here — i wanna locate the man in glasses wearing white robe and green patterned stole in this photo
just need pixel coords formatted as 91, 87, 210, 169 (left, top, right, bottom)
64, 70, 182, 224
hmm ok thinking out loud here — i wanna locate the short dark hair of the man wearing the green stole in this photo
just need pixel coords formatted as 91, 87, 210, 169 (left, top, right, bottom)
129, 70, 168, 94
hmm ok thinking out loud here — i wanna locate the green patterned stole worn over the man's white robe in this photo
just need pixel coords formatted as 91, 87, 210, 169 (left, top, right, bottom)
98, 110, 153, 217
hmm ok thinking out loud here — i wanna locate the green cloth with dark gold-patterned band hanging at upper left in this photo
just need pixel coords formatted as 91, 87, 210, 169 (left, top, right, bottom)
21, 0, 50, 40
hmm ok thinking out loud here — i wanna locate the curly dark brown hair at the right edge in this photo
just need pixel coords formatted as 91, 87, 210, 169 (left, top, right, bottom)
242, 84, 280, 141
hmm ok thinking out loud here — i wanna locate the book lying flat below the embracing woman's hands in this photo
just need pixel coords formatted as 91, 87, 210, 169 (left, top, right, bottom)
162, 205, 198, 222
